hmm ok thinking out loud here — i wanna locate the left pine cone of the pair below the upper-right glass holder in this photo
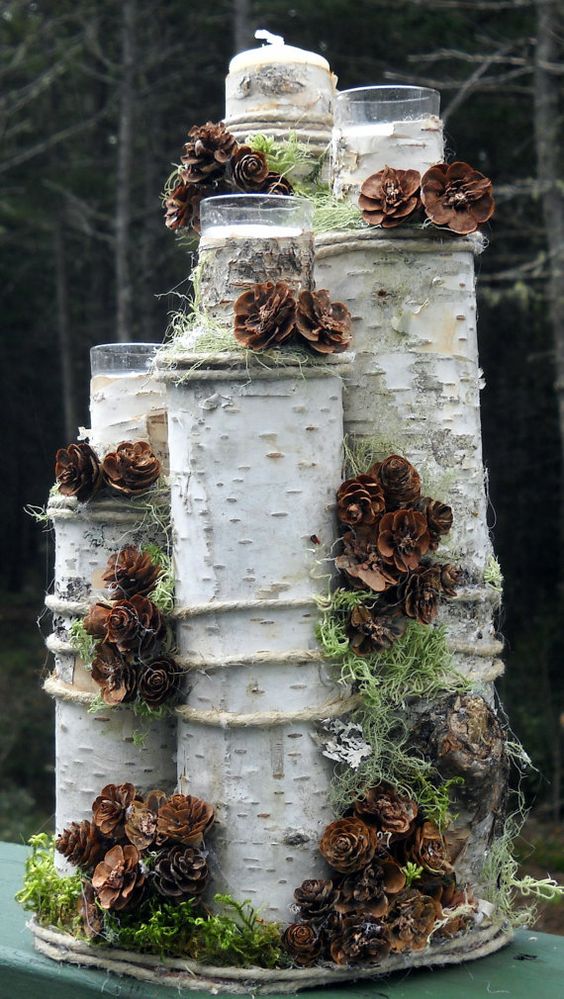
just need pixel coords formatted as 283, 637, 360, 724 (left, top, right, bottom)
358, 166, 421, 229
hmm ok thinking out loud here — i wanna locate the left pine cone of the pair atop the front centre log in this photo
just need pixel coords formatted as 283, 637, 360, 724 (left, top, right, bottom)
233, 281, 296, 350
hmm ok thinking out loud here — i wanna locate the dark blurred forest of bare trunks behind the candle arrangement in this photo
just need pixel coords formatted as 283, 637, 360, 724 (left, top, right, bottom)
0, 0, 564, 926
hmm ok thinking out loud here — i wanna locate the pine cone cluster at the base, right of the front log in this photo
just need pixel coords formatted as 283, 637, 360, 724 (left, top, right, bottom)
282, 784, 477, 967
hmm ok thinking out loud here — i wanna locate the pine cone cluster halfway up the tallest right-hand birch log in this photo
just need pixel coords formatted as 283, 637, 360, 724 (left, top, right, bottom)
335, 454, 460, 656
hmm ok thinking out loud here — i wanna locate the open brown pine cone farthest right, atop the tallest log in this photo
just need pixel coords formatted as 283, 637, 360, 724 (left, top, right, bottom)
421, 161, 495, 235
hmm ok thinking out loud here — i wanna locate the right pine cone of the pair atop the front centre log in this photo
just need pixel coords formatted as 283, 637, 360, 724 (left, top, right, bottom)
296, 288, 352, 354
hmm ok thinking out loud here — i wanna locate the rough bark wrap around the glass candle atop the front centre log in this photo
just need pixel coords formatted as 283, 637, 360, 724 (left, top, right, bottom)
199, 233, 313, 325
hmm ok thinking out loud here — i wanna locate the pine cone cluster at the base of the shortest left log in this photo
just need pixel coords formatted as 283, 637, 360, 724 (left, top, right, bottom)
56, 784, 214, 937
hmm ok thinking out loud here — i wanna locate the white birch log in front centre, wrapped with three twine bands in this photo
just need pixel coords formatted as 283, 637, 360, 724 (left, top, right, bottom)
158, 355, 347, 921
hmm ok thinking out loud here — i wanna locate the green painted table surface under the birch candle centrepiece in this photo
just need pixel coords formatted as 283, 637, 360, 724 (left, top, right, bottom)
0, 843, 564, 999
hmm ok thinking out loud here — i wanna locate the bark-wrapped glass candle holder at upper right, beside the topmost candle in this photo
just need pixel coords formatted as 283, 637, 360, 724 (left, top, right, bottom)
332, 86, 444, 201
